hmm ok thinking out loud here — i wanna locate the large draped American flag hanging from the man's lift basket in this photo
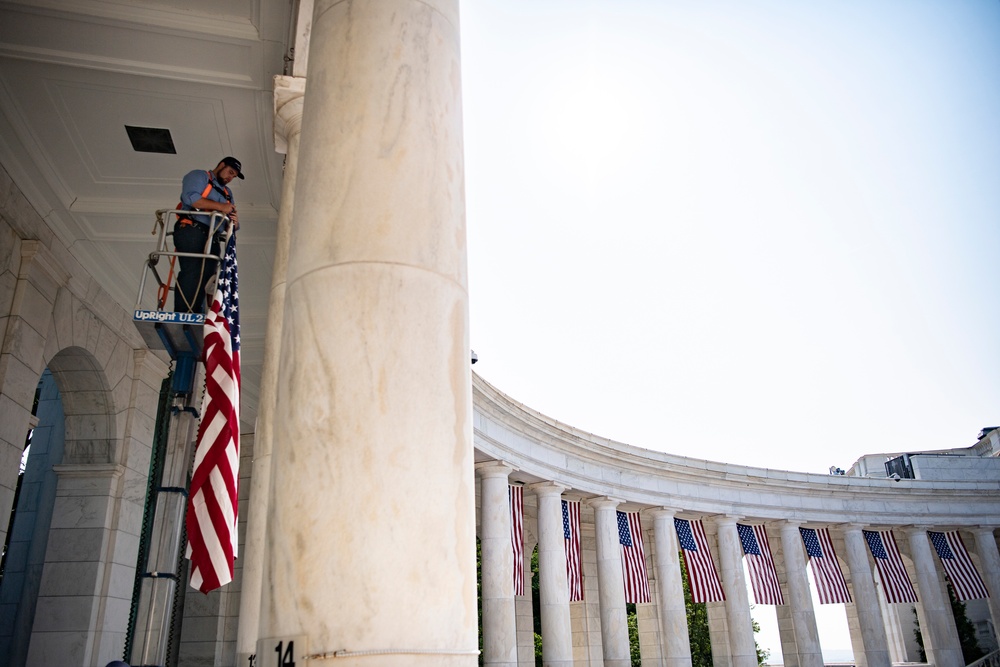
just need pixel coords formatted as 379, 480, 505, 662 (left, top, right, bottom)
187, 234, 240, 593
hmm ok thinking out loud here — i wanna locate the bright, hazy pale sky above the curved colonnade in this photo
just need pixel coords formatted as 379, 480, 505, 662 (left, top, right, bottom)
462, 0, 1000, 650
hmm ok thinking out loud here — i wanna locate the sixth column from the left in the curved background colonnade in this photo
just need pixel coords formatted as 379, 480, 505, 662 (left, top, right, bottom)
780, 521, 823, 667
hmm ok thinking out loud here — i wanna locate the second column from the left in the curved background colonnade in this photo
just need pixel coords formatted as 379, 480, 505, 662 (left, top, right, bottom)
529, 482, 573, 667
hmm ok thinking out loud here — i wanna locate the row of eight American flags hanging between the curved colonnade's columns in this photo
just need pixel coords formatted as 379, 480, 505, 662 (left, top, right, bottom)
510, 485, 989, 605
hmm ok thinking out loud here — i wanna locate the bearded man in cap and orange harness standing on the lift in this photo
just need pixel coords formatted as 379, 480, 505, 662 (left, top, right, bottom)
174, 157, 243, 313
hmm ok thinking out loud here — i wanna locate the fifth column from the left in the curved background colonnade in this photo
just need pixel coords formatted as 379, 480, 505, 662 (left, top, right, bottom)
715, 514, 757, 667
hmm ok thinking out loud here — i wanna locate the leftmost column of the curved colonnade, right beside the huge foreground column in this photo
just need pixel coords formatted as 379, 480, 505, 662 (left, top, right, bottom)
476, 461, 517, 667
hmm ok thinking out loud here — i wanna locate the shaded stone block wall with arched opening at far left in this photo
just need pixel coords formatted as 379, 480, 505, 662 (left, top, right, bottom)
0, 163, 167, 665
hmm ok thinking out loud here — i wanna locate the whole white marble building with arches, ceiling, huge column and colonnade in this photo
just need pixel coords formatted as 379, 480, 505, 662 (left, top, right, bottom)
0, 0, 1000, 667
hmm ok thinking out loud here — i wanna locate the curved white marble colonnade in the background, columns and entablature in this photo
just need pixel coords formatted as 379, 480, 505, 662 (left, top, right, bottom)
473, 375, 1000, 667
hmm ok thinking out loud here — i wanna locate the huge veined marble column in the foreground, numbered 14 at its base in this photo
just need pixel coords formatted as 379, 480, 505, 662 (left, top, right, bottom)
258, 0, 478, 667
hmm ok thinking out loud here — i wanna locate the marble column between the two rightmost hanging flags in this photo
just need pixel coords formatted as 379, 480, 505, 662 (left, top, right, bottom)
905, 526, 965, 667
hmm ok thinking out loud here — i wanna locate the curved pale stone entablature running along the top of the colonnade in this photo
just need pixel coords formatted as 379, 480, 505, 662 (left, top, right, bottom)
473, 374, 1000, 527
